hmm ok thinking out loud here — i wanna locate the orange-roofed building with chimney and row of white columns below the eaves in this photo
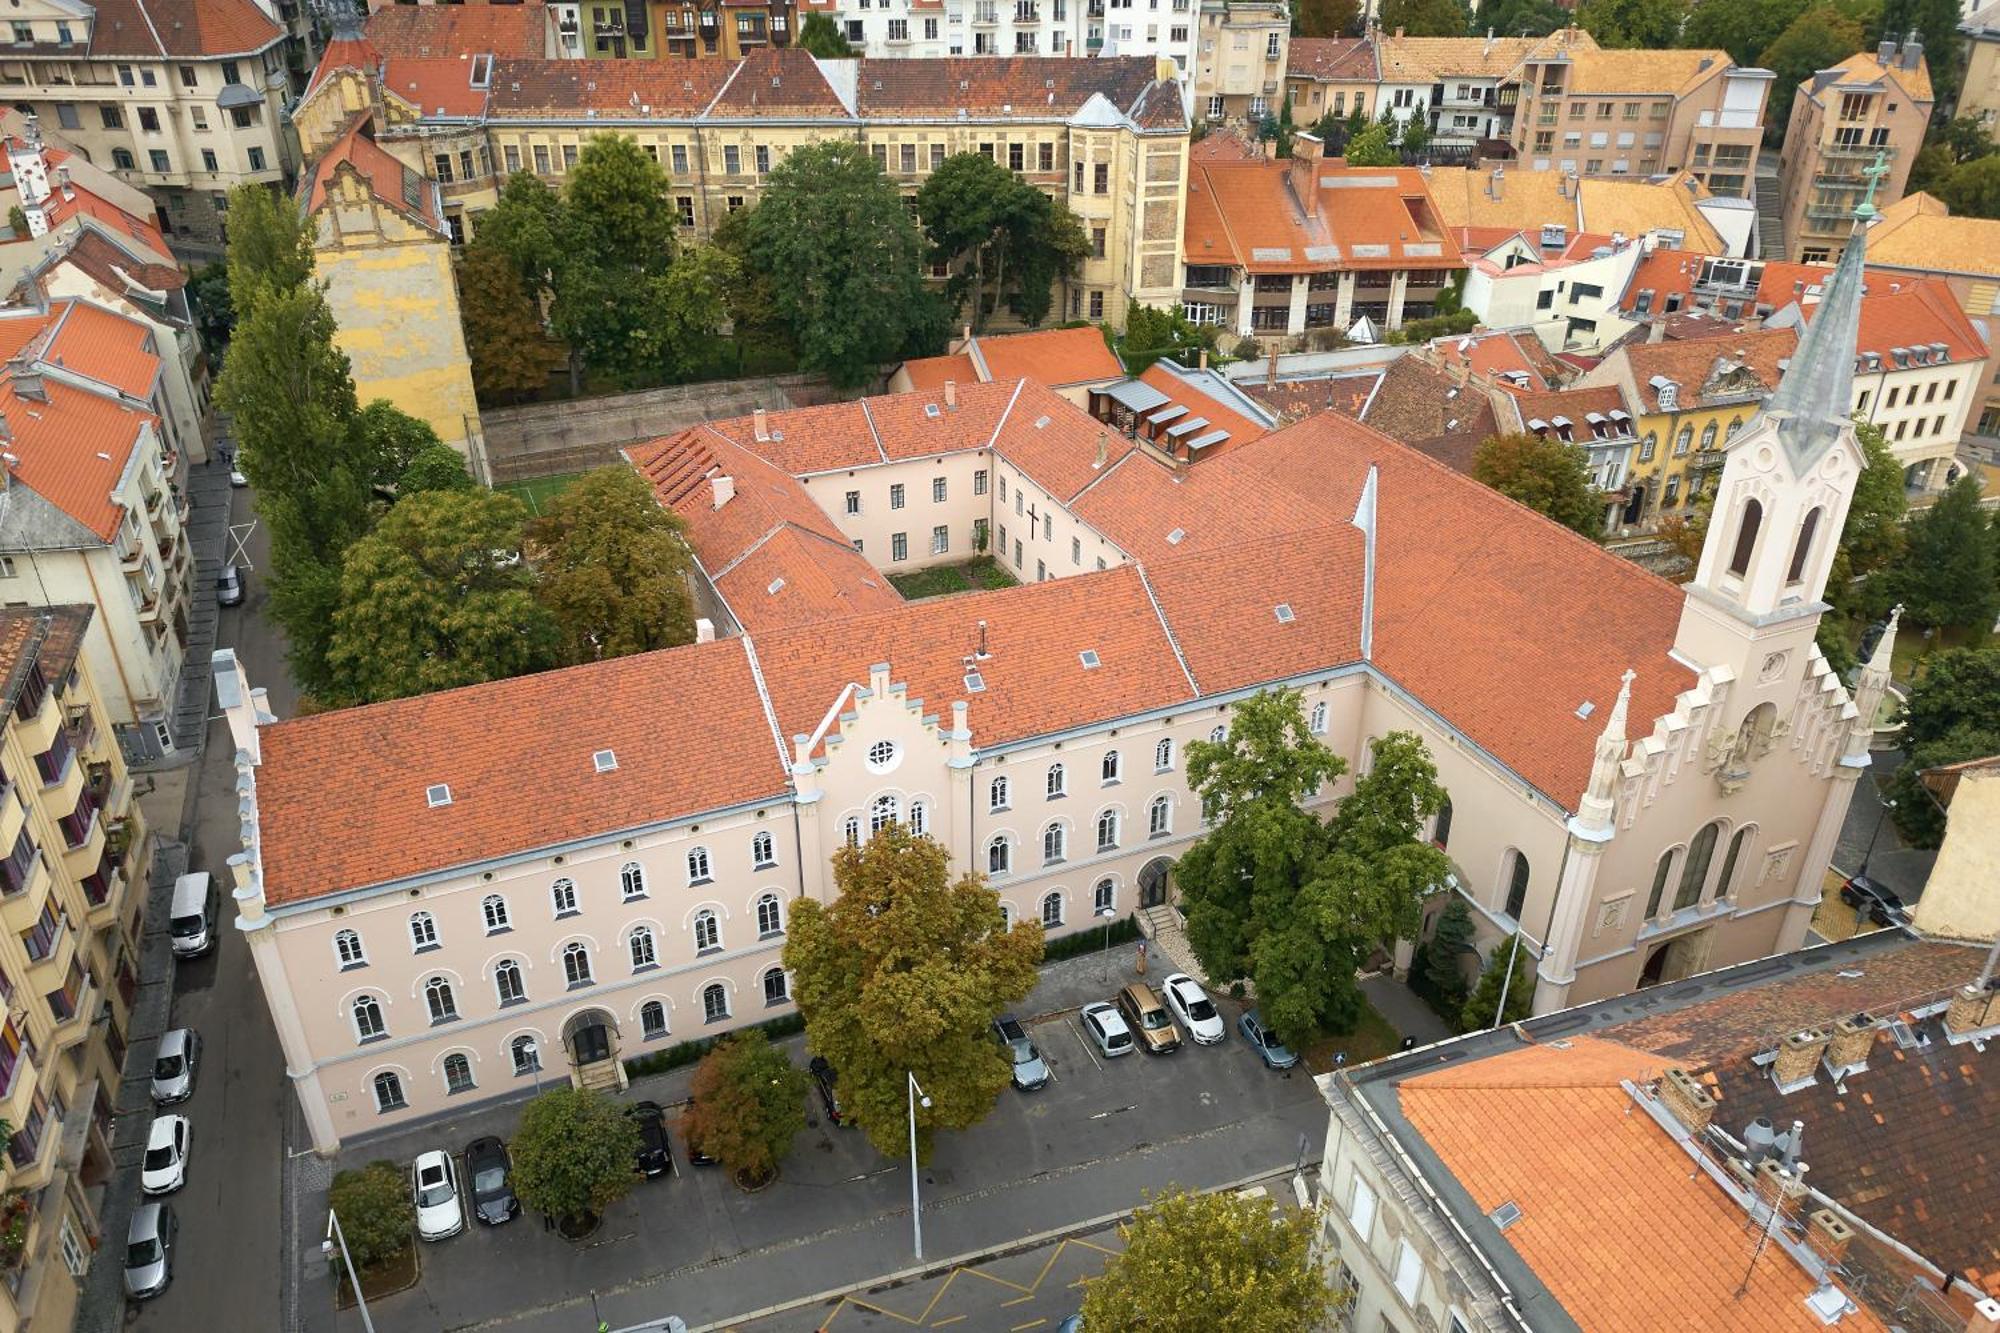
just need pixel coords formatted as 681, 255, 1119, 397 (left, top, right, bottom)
1180, 132, 1464, 338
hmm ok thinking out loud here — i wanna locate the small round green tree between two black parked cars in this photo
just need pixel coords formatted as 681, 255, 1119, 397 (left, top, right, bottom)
508, 1087, 640, 1221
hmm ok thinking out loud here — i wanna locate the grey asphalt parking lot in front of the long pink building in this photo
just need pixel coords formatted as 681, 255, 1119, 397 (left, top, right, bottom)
286, 949, 1326, 1331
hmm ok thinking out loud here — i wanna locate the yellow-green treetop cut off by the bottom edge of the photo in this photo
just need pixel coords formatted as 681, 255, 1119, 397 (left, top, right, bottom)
1082, 1189, 1342, 1333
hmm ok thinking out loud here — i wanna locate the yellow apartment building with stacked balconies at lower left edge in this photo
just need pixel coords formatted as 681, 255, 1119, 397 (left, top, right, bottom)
0, 606, 152, 1333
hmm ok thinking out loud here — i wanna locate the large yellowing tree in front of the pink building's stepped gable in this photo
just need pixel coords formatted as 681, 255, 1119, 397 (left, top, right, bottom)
784, 823, 1042, 1159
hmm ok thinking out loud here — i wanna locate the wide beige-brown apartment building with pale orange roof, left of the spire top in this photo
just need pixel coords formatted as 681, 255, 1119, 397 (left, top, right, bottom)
1514, 34, 1772, 198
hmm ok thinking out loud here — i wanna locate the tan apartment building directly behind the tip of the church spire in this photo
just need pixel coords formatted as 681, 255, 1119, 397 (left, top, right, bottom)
1778, 36, 1936, 264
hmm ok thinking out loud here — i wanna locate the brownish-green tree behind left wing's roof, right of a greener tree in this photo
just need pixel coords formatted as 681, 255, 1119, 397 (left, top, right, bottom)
528, 464, 694, 662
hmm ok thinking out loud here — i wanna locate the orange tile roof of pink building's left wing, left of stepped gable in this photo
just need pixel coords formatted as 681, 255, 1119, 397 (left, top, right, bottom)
258, 638, 796, 905
